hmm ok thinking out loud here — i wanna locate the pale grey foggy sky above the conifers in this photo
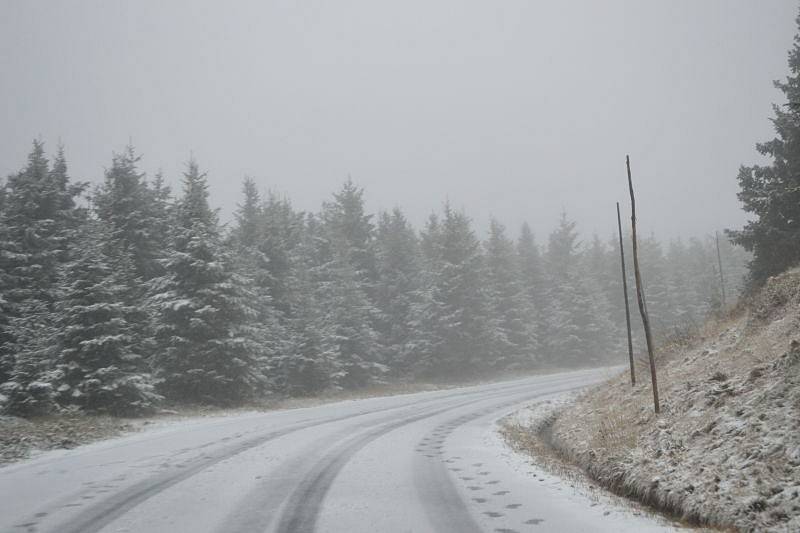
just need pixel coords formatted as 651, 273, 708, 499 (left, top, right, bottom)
0, 0, 798, 242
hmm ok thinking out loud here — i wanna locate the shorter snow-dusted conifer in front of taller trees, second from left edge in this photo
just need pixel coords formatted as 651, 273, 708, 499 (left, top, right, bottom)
54, 221, 160, 415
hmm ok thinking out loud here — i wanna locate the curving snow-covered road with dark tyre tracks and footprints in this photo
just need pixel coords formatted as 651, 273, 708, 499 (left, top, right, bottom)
0, 370, 680, 533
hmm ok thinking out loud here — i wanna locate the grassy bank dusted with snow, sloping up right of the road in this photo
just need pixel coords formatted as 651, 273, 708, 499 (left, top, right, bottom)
510, 269, 800, 531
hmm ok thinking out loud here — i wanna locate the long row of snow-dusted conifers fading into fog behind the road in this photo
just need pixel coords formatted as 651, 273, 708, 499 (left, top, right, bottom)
0, 141, 748, 415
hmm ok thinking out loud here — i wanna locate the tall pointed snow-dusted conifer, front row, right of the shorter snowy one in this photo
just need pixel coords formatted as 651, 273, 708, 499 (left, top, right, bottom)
152, 161, 264, 405
